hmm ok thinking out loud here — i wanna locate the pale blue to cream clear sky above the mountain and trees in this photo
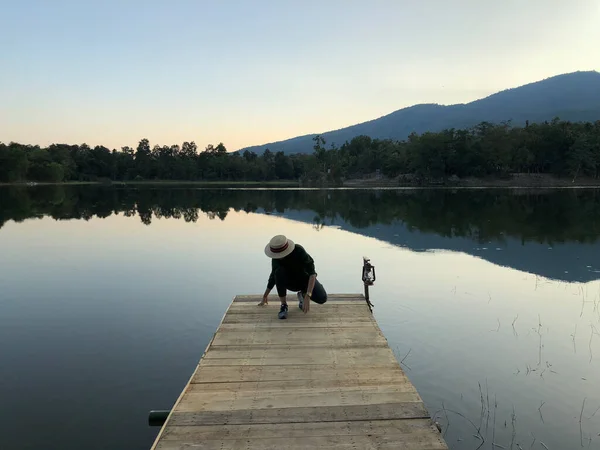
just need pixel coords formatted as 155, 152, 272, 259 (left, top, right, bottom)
0, 0, 600, 150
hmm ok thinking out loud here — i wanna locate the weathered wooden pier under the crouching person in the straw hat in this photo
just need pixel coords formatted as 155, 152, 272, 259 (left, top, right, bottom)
152, 295, 448, 450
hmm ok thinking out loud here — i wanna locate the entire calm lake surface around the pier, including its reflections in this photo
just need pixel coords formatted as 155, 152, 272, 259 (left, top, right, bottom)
0, 186, 600, 450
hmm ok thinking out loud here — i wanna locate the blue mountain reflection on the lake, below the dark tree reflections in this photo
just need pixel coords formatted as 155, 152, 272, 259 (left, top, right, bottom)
278, 210, 600, 282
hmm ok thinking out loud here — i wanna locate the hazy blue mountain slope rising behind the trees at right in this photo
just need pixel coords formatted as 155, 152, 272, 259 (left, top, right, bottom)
240, 71, 600, 154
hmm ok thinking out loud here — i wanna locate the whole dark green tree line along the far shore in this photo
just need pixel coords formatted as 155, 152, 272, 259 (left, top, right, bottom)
0, 118, 600, 183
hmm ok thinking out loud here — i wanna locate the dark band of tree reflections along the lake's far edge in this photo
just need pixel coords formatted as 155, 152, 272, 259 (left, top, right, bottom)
0, 186, 600, 243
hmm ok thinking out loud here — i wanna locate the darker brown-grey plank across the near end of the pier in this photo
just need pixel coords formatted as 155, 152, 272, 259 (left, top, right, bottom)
166, 402, 429, 426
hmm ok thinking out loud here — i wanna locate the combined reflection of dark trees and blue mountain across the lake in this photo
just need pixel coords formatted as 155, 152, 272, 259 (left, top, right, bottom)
0, 186, 600, 281
